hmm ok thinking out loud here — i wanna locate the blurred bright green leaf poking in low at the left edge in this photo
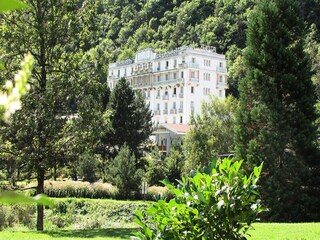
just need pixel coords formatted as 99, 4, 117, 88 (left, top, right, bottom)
0, 191, 53, 207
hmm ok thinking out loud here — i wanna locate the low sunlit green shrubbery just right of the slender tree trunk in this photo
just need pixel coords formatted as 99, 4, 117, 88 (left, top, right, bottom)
46, 199, 149, 229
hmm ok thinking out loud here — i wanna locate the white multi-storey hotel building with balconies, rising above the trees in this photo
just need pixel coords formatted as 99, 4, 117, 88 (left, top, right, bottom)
107, 47, 227, 124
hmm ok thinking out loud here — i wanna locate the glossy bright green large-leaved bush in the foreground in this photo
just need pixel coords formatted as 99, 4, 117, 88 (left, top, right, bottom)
135, 159, 263, 239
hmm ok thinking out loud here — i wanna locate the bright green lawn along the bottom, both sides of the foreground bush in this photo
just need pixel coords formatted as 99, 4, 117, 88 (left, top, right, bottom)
0, 223, 320, 240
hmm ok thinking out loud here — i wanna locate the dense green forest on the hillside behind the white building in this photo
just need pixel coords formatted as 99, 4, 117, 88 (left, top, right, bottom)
75, 0, 320, 96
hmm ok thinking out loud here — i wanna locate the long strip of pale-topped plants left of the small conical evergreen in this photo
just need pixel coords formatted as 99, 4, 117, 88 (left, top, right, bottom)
44, 181, 117, 198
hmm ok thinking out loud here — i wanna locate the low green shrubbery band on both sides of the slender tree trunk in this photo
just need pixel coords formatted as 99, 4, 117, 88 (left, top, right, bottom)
0, 198, 150, 230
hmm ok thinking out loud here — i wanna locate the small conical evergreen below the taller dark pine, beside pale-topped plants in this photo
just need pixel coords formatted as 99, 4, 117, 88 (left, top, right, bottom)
110, 144, 144, 198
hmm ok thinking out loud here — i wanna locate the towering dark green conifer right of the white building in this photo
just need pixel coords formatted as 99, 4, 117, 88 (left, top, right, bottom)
235, 0, 319, 221
